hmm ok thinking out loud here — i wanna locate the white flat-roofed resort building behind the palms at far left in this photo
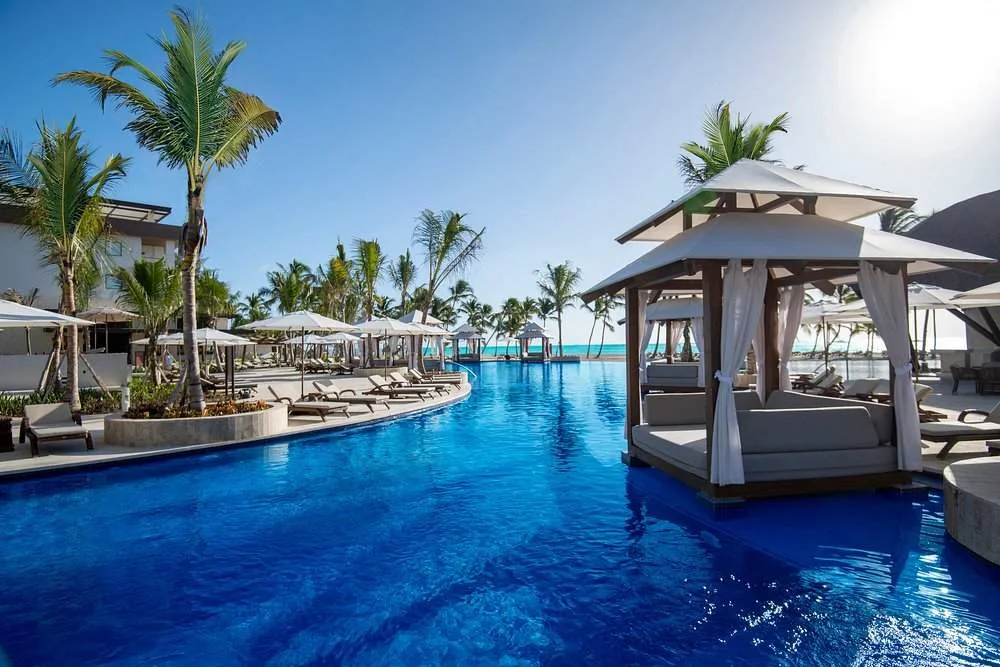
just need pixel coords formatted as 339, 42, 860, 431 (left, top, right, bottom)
0, 199, 181, 354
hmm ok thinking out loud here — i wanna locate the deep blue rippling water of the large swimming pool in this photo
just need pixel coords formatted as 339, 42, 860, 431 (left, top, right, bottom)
0, 363, 1000, 667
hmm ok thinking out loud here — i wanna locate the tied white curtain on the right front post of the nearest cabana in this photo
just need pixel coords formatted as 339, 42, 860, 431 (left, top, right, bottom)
858, 262, 923, 472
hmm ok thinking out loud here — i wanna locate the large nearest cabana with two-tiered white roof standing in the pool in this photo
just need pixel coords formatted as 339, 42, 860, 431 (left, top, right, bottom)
582, 161, 994, 499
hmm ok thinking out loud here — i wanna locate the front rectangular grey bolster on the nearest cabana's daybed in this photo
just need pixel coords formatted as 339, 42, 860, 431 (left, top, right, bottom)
737, 406, 879, 454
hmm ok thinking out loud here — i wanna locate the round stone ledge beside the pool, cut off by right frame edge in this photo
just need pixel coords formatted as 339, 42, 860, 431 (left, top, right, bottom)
944, 457, 1000, 565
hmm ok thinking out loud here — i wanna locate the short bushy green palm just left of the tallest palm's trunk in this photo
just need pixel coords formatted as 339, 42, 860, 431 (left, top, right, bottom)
114, 258, 184, 383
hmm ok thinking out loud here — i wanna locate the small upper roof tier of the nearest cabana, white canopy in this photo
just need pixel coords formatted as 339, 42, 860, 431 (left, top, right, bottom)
617, 159, 916, 243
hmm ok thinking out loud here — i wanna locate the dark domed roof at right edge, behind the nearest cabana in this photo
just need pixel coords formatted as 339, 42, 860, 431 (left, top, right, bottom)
906, 190, 1000, 292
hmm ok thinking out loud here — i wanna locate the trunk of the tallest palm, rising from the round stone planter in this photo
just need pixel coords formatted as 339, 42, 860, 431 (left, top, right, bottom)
181, 174, 205, 412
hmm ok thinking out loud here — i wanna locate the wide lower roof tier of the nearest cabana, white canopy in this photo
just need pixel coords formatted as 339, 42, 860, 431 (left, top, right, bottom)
582, 213, 995, 301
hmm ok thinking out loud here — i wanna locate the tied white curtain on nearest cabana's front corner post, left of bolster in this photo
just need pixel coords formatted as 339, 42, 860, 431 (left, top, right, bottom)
711, 259, 767, 485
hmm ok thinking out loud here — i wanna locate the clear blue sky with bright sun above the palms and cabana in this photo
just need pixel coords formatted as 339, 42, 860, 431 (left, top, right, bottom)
0, 0, 1000, 343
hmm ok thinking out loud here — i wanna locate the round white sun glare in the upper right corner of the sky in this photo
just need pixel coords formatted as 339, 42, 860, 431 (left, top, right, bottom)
842, 0, 1000, 129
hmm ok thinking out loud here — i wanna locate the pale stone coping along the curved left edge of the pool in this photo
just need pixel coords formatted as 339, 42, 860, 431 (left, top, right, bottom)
0, 383, 472, 484
